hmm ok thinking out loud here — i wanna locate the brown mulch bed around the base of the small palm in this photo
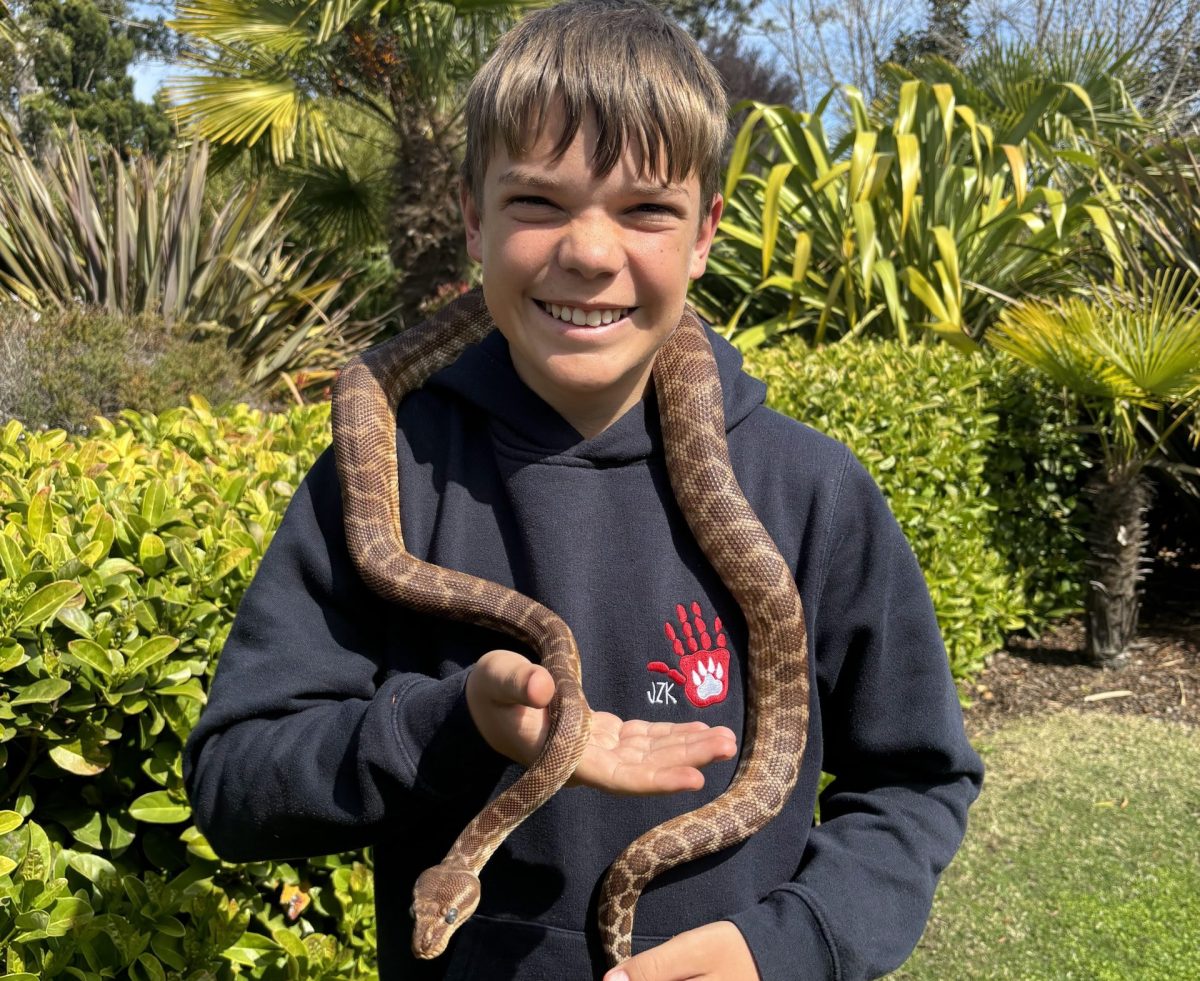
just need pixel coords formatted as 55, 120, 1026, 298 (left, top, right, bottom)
964, 558, 1200, 734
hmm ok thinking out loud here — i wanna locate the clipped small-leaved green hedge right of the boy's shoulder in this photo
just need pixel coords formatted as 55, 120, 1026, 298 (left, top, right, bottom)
746, 338, 1099, 678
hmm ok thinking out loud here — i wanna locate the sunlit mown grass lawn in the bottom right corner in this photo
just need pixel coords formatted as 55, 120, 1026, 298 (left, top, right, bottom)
890, 712, 1200, 981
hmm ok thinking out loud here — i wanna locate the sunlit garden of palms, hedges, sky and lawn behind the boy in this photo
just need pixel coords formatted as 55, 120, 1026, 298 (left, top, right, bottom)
0, 0, 1200, 981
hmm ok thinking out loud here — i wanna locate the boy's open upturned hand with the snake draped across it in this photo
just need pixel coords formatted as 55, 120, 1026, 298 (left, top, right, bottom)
467, 650, 737, 791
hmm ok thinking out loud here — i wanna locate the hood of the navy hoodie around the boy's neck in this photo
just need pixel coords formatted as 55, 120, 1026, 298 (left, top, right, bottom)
426, 314, 767, 467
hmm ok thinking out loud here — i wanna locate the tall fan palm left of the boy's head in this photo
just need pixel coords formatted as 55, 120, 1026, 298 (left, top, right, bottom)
170, 0, 532, 319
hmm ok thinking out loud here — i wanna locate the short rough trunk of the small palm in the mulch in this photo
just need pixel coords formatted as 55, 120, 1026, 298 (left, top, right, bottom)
1087, 465, 1151, 668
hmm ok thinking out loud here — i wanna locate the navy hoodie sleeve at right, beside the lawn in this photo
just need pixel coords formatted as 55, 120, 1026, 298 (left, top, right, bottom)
731, 457, 983, 981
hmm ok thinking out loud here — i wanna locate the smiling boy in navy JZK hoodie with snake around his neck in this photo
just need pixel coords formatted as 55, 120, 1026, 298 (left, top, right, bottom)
185, 0, 982, 981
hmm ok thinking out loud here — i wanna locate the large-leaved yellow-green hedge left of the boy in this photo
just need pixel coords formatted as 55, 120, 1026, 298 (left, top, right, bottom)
0, 399, 374, 981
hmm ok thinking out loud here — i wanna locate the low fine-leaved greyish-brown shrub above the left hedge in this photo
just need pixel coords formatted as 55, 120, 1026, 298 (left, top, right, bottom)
0, 303, 247, 431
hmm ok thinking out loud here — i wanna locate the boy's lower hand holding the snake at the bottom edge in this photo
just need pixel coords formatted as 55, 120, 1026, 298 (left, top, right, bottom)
604, 920, 758, 981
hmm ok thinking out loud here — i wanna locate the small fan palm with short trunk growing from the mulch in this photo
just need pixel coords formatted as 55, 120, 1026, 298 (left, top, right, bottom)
988, 270, 1200, 667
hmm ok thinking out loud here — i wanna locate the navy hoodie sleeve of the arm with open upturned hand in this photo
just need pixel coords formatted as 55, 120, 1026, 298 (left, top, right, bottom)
184, 451, 503, 861
